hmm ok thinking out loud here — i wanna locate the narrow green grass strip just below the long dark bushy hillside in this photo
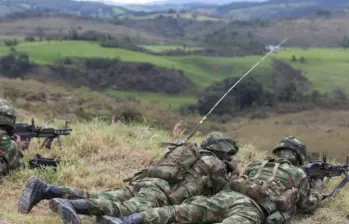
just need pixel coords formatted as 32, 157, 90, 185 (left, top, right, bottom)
105, 89, 196, 110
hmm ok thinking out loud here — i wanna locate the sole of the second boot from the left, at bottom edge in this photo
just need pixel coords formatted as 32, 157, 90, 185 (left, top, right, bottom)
49, 198, 81, 224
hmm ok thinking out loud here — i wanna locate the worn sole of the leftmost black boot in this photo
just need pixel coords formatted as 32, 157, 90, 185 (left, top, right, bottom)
18, 177, 46, 213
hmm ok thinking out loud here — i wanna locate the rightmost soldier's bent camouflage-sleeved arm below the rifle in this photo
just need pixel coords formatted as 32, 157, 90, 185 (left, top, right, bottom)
297, 177, 322, 213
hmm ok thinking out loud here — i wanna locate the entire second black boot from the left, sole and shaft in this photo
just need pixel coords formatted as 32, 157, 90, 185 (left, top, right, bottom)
49, 198, 90, 224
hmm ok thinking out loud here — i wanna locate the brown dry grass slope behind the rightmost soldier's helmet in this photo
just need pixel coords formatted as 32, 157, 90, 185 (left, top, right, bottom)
223, 109, 349, 162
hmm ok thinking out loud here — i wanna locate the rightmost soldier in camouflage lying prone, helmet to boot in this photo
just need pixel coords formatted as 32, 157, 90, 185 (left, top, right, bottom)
99, 136, 323, 224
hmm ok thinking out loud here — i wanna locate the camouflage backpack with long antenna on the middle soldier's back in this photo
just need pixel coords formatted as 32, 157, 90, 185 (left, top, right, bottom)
124, 143, 201, 184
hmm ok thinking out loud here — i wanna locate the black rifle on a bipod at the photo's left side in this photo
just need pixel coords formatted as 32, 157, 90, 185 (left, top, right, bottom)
14, 119, 72, 150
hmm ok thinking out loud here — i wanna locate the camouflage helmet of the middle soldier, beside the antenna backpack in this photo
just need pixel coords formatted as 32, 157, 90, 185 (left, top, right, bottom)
200, 132, 239, 155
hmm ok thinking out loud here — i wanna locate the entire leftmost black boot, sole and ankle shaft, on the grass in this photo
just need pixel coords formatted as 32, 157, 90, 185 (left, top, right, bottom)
18, 177, 64, 213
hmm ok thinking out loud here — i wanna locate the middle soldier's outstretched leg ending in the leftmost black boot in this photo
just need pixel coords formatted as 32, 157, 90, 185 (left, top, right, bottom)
18, 177, 133, 213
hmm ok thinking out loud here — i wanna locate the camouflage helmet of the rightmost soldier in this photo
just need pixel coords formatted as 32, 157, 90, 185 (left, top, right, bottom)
273, 136, 307, 165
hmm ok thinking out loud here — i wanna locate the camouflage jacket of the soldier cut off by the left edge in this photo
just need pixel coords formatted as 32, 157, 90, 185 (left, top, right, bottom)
0, 130, 23, 176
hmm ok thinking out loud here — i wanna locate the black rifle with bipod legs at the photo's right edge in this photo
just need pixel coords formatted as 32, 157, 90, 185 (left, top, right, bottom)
303, 156, 349, 199
